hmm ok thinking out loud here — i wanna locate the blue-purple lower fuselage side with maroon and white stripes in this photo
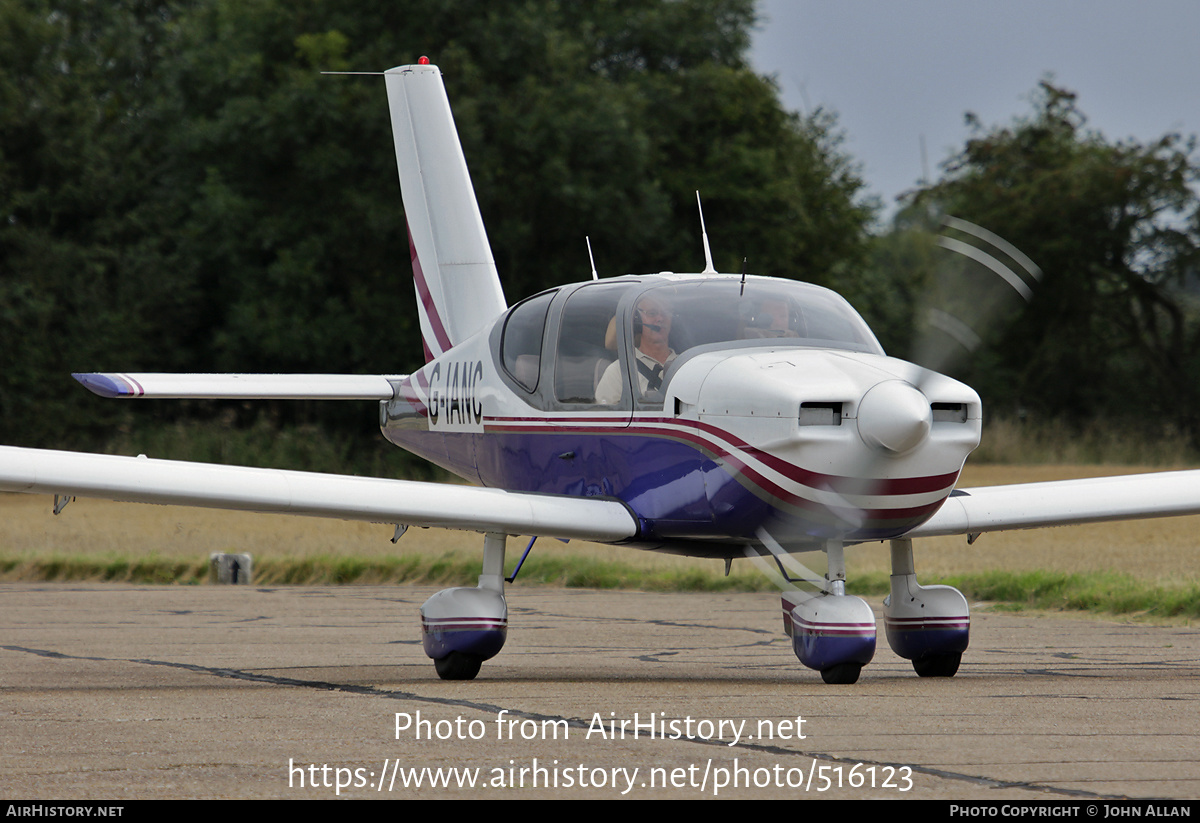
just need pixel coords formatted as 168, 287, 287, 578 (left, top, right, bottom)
385, 415, 958, 543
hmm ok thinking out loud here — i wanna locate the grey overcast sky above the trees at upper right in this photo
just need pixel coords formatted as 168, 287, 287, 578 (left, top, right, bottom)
751, 0, 1200, 217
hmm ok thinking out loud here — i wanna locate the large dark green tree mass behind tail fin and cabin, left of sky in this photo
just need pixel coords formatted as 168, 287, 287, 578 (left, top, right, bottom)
0, 0, 871, 470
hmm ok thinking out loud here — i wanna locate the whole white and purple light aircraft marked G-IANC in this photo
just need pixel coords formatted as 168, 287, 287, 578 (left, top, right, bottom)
0, 59, 1200, 683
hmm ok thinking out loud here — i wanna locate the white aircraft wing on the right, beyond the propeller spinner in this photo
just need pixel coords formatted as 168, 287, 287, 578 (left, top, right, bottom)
905, 471, 1200, 537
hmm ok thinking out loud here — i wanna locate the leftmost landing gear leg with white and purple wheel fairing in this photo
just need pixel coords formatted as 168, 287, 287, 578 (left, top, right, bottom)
421, 534, 509, 680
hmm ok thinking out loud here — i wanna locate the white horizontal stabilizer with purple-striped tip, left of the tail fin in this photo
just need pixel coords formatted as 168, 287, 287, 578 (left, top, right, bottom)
72, 372, 404, 400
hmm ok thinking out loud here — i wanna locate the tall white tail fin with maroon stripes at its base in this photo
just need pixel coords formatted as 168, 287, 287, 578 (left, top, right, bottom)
384, 65, 508, 361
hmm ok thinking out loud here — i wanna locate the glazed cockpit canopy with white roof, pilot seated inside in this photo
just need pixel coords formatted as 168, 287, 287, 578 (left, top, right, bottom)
498, 275, 883, 409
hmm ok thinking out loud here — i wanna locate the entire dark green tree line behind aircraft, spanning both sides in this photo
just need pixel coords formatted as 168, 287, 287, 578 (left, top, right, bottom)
0, 0, 1200, 468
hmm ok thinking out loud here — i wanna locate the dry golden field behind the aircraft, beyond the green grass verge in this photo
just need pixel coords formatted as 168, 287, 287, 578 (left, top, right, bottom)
0, 465, 1200, 582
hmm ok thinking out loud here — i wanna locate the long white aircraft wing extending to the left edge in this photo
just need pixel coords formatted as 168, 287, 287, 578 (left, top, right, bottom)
0, 446, 637, 542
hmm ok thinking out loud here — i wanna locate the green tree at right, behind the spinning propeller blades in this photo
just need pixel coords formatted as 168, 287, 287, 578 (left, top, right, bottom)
870, 80, 1200, 444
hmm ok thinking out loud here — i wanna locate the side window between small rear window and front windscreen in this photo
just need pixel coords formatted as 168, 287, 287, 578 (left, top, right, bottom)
554, 283, 634, 404
